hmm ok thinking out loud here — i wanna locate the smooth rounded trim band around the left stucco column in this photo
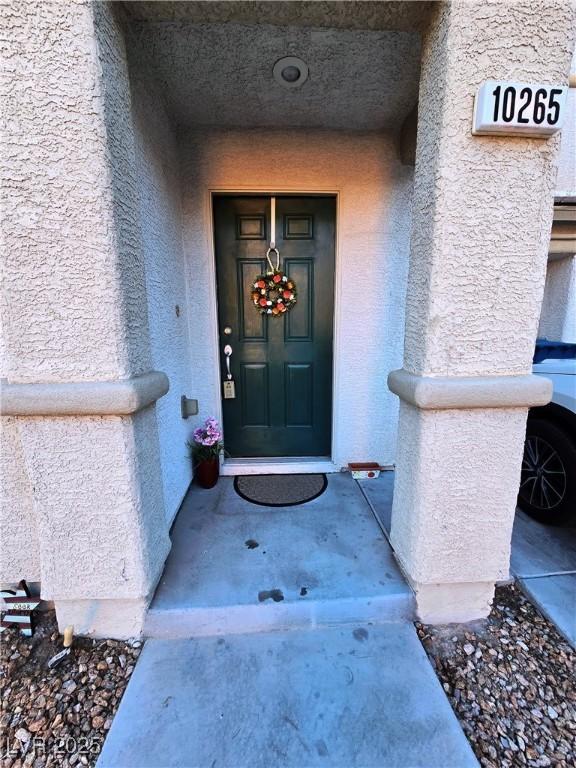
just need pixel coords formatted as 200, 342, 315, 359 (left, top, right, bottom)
0, 371, 170, 416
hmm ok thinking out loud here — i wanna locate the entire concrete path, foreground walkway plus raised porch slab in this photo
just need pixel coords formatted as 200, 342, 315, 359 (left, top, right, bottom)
98, 475, 478, 768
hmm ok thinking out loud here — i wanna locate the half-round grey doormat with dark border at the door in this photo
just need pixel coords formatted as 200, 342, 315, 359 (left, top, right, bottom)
234, 475, 328, 507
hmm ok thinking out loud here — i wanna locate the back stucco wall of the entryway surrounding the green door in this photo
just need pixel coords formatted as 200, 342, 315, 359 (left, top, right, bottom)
180, 130, 413, 466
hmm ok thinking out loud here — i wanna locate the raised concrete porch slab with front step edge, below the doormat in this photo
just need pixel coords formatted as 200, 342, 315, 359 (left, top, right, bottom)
145, 474, 414, 639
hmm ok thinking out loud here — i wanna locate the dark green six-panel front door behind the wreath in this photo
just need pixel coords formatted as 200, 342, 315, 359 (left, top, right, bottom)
214, 196, 336, 457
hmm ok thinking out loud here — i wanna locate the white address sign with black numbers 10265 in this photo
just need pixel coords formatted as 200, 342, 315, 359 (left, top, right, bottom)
472, 80, 568, 136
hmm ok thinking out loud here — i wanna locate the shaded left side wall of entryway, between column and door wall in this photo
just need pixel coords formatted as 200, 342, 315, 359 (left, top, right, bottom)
130, 70, 192, 520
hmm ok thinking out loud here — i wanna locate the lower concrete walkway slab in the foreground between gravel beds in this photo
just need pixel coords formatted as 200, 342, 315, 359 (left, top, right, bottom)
98, 623, 478, 768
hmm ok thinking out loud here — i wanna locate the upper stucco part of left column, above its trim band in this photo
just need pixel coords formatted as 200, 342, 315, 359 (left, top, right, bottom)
0, 2, 150, 381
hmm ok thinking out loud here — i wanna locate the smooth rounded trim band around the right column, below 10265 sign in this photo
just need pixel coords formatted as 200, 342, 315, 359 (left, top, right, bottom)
388, 368, 552, 410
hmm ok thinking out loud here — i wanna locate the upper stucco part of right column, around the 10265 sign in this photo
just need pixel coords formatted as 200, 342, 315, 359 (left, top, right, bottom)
404, 0, 575, 375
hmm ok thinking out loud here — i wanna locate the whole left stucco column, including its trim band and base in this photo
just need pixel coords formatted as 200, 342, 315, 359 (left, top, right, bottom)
0, 2, 169, 637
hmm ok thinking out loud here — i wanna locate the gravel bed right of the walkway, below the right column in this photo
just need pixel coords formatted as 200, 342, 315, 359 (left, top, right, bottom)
417, 586, 576, 768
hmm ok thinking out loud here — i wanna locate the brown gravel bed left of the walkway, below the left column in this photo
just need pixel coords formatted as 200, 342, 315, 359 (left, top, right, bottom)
0, 611, 141, 768
